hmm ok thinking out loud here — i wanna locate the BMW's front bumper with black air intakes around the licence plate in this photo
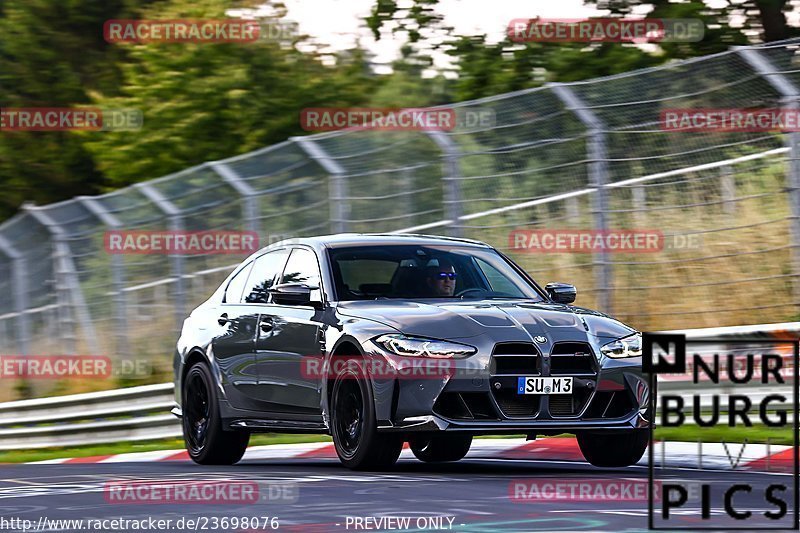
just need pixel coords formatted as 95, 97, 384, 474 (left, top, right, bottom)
373, 336, 652, 435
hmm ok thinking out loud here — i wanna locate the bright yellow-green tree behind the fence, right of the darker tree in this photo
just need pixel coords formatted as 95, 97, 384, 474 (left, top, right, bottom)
86, 0, 377, 187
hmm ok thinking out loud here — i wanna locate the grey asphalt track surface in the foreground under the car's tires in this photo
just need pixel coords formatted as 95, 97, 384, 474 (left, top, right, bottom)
0, 458, 793, 532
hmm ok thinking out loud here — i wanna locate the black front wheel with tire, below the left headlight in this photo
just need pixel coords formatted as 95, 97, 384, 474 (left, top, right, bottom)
330, 360, 403, 470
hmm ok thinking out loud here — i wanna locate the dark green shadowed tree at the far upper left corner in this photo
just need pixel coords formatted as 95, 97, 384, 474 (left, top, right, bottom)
0, 0, 145, 218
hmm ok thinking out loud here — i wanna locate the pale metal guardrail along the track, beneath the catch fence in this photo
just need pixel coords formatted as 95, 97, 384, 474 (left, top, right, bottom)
0, 322, 800, 450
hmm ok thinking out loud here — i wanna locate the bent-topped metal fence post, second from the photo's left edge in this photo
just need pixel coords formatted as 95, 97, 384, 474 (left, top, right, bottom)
22, 203, 99, 354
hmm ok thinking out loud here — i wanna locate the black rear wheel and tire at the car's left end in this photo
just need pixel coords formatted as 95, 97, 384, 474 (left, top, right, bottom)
182, 363, 250, 465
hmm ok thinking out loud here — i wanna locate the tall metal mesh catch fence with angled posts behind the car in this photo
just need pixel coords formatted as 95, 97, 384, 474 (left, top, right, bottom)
0, 41, 800, 382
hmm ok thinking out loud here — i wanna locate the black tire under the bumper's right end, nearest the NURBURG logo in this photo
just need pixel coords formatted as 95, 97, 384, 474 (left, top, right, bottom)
577, 429, 649, 467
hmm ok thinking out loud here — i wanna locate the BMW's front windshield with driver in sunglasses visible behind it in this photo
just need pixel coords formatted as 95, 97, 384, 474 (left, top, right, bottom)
328, 244, 542, 301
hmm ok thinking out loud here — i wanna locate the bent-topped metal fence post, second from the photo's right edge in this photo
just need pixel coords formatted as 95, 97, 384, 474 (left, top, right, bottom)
549, 83, 613, 314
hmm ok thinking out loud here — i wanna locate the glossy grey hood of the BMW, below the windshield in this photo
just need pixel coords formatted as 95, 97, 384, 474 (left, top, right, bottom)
337, 300, 635, 341
